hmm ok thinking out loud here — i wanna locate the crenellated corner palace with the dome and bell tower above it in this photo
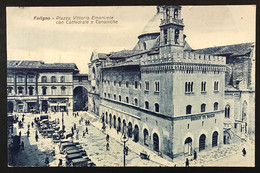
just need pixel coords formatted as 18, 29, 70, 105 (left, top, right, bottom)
89, 6, 226, 159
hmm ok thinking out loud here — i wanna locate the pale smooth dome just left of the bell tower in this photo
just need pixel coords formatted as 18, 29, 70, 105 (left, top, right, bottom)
139, 12, 163, 37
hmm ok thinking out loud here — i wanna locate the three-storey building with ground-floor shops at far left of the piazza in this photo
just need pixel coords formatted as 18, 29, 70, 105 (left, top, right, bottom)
7, 60, 78, 113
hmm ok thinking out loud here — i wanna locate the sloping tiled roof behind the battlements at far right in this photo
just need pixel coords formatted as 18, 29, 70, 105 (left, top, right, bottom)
193, 43, 253, 56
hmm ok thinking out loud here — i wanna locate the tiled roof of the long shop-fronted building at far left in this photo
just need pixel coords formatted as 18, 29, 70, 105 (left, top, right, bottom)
7, 60, 78, 69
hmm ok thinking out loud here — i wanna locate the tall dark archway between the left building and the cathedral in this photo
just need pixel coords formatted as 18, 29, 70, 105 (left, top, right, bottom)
73, 86, 88, 111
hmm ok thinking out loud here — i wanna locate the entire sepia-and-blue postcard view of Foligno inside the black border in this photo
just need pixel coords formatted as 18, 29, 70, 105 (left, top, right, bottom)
6, 5, 256, 167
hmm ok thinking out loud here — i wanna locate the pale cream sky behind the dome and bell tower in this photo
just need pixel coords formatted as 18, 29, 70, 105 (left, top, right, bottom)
6, 5, 256, 73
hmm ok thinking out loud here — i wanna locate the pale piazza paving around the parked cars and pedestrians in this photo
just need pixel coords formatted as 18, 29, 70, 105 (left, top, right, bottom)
7, 112, 254, 167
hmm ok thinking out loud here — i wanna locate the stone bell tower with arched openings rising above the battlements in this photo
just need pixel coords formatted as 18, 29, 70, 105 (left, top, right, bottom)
160, 6, 184, 53
